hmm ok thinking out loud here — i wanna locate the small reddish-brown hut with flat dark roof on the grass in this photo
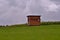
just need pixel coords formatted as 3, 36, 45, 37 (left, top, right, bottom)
27, 15, 41, 26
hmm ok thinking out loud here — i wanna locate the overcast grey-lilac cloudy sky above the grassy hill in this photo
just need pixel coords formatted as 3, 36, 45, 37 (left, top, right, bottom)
0, 0, 60, 25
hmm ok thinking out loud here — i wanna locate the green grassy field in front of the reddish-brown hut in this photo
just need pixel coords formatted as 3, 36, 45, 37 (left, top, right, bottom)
0, 25, 60, 40
